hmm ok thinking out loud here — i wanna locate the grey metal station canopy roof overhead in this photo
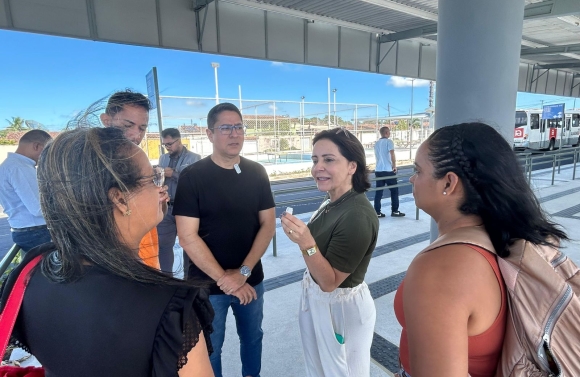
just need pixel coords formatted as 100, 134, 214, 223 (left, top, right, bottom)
0, 0, 580, 97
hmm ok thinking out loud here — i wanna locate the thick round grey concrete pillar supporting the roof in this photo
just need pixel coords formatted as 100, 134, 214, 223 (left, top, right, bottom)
431, 0, 525, 240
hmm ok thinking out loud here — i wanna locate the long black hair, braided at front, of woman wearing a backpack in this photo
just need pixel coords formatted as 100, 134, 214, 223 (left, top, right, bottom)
426, 122, 568, 257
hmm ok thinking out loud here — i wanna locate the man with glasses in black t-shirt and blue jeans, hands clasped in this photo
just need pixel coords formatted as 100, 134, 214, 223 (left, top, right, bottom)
173, 103, 276, 377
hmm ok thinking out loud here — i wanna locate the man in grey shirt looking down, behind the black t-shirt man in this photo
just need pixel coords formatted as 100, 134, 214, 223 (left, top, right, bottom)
157, 128, 201, 273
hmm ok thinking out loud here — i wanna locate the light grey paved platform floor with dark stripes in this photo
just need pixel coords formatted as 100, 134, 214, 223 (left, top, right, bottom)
4, 167, 580, 377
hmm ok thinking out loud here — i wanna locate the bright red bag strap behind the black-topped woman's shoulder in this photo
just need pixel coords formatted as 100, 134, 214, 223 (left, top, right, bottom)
0, 255, 42, 359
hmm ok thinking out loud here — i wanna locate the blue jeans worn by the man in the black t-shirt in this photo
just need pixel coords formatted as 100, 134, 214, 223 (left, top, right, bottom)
209, 282, 264, 377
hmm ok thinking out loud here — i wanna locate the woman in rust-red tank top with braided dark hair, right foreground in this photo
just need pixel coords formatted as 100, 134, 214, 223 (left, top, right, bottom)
394, 123, 567, 377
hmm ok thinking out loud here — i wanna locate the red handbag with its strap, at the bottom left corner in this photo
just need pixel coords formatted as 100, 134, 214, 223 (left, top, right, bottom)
0, 255, 44, 377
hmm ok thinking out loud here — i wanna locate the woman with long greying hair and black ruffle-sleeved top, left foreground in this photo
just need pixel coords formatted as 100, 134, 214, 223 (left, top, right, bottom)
1, 128, 213, 377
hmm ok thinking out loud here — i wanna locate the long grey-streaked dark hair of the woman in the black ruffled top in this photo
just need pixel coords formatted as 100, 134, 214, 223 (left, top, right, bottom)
38, 127, 199, 286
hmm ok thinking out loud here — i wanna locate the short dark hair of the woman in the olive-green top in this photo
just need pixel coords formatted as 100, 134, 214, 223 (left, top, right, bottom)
312, 127, 371, 192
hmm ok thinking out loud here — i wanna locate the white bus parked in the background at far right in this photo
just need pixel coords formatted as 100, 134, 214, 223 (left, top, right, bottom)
514, 109, 580, 151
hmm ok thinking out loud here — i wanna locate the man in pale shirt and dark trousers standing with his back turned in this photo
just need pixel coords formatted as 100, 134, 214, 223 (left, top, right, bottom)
375, 127, 405, 217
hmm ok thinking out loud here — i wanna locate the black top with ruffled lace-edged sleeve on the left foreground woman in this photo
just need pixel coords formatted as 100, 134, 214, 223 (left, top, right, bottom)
5, 258, 213, 377
